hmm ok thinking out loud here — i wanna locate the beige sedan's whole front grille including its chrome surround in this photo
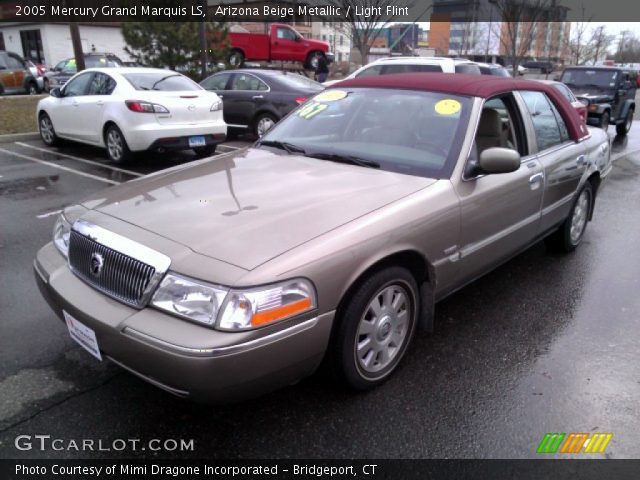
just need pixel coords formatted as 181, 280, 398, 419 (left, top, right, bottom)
69, 220, 171, 308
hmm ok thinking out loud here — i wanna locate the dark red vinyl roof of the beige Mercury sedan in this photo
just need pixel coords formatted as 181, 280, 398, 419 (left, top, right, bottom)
336, 73, 589, 141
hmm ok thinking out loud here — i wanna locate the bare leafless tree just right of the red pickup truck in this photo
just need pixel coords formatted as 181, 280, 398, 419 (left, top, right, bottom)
327, 0, 414, 63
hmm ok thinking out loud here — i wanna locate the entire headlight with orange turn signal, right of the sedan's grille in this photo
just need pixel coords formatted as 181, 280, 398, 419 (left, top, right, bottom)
151, 273, 316, 331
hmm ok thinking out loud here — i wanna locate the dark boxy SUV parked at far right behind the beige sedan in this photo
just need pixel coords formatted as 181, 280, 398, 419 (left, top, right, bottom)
560, 67, 637, 135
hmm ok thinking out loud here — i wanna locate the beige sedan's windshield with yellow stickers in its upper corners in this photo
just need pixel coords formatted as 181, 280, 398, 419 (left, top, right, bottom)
257, 88, 471, 178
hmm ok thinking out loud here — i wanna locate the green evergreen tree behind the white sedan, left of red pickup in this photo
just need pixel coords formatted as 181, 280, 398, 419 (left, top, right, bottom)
122, 22, 228, 77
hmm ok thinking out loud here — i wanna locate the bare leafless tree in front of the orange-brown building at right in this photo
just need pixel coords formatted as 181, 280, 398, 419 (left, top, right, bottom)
490, 0, 557, 76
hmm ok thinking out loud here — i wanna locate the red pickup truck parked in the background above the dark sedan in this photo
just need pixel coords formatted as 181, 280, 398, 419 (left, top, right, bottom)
229, 23, 333, 69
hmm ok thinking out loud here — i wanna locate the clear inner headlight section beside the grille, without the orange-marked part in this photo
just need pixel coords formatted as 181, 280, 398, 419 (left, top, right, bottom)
151, 273, 228, 325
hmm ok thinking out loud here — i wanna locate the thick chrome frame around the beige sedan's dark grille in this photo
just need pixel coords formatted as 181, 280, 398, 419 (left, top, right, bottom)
67, 219, 171, 309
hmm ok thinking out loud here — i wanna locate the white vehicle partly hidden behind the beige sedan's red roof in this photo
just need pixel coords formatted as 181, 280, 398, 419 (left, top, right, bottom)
323, 57, 480, 87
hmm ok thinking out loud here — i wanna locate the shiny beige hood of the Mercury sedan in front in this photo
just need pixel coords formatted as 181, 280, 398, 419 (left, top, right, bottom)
83, 148, 436, 270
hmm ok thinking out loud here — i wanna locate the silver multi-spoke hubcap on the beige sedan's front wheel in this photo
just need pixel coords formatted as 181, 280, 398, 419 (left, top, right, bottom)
355, 284, 411, 373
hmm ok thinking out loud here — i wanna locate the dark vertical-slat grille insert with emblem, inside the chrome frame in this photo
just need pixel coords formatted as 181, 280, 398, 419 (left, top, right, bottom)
69, 230, 156, 308
